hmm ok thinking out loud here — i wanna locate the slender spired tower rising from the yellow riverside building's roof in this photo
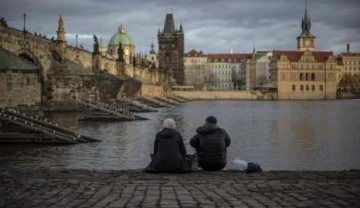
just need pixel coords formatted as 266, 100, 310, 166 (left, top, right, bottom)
297, 7, 316, 51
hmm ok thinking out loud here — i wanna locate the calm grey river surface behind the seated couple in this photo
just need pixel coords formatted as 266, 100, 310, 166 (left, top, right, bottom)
0, 100, 360, 170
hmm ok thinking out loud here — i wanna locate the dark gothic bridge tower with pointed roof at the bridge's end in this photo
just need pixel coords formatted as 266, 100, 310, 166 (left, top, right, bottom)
158, 14, 184, 85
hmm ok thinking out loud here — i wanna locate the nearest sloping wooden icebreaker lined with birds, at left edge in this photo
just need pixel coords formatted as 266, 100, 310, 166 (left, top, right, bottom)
0, 107, 100, 144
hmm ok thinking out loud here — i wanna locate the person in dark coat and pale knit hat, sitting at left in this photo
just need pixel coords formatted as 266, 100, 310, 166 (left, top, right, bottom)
145, 118, 191, 173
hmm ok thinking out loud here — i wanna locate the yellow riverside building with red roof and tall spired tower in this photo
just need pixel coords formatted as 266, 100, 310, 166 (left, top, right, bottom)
271, 9, 337, 100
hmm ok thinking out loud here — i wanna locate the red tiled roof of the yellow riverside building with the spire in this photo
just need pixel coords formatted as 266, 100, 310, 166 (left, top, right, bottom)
275, 51, 333, 62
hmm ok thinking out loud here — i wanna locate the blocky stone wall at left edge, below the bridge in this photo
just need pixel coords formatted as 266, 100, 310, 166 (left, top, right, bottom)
0, 70, 41, 110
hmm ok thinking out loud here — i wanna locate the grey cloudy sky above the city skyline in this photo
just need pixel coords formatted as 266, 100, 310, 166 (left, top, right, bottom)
0, 0, 360, 53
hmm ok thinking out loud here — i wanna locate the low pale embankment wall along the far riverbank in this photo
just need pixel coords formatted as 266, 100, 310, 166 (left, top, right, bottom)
172, 91, 277, 100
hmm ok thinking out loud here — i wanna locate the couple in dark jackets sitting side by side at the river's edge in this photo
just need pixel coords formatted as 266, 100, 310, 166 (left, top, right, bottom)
145, 116, 231, 173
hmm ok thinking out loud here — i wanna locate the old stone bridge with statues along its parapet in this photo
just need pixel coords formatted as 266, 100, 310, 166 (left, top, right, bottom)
0, 17, 158, 110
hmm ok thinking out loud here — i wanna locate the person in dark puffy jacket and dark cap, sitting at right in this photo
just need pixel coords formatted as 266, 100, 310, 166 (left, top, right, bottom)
190, 116, 231, 171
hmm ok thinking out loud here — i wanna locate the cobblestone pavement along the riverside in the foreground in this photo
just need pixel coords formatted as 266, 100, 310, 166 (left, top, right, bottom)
0, 165, 360, 208
